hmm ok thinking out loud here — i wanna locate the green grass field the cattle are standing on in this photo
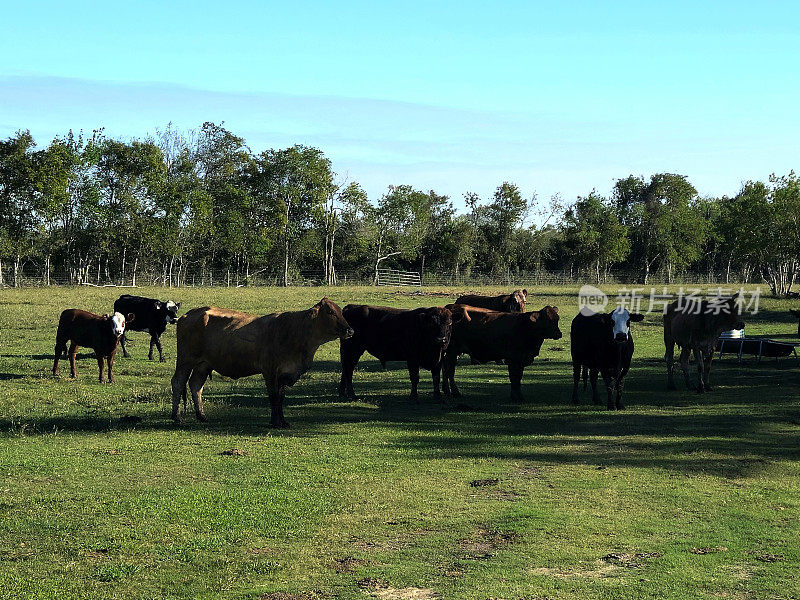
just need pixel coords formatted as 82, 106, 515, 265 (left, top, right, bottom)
0, 288, 800, 600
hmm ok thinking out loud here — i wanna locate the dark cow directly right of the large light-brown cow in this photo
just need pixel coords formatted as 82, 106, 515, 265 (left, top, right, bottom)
339, 304, 453, 401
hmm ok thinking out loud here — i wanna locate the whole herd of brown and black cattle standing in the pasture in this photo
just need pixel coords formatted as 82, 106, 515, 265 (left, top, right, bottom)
53, 289, 744, 427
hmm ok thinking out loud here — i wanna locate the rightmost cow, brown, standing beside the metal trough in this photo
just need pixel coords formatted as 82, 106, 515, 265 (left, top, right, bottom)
664, 294, 744, 394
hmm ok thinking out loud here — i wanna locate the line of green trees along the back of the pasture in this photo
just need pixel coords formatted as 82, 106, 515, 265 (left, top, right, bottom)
0, 123, 800, 294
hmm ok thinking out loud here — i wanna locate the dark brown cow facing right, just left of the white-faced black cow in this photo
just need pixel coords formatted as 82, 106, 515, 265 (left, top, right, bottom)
443, 304, 561, 402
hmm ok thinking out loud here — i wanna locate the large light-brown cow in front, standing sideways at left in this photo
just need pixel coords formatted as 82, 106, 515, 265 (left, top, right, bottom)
172, 298, 353, 427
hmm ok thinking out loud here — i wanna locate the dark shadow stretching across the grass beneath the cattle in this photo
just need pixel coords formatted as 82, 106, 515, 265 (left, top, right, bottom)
6, 360, 800, 478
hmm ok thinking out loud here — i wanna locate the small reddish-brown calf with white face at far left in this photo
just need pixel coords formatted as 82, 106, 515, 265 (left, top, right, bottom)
53, 308, 135, 383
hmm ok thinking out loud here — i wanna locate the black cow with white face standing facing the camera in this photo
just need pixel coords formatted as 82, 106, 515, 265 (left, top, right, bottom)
570, 308, 644, 410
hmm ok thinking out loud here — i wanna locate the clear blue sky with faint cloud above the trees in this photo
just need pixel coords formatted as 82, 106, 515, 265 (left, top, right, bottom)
0, 0, 800, 210
